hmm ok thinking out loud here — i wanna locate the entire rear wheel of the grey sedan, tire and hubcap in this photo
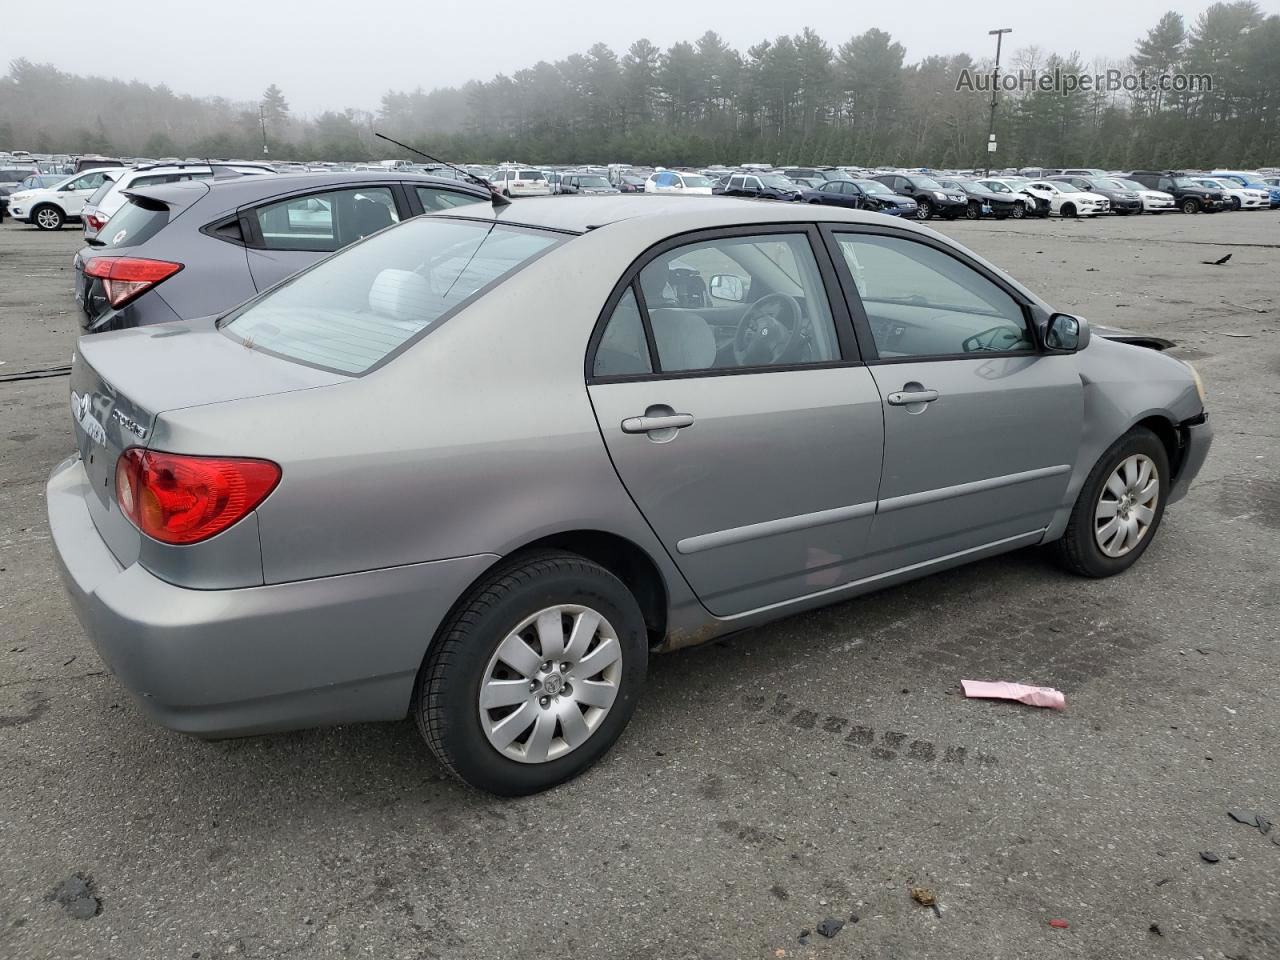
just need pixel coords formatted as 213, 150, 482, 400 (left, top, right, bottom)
413, 552, 649, 796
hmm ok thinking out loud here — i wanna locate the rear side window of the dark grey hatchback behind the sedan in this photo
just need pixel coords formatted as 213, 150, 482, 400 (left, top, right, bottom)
252, 187, 399, 252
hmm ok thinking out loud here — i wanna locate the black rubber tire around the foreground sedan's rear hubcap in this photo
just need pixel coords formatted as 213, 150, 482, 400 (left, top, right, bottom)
412, 550, 649, 796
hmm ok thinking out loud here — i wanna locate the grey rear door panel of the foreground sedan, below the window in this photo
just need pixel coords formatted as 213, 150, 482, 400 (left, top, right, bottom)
589, 366, 884, 616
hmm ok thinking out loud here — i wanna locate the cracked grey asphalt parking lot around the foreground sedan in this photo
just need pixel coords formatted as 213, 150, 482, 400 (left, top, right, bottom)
0, 211, 1280, 960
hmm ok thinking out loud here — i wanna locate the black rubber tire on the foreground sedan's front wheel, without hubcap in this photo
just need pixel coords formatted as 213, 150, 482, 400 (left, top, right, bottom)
1053, 426, 1172, 577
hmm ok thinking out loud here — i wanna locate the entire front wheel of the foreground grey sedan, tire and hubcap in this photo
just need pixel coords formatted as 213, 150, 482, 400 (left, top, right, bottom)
1055, 428, 1172, 577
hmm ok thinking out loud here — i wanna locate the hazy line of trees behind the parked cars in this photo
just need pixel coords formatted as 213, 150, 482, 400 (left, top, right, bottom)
0, 0, 1280, 169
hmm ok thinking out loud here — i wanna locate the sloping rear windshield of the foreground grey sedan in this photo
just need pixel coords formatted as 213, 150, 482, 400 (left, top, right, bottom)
220, 216, 564, 374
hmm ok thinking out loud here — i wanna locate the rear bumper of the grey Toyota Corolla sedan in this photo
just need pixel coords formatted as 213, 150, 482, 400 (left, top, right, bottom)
46, 457, 497, 737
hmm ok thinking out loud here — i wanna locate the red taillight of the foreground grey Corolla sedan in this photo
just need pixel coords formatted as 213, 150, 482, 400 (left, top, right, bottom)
115, 447, 280, 544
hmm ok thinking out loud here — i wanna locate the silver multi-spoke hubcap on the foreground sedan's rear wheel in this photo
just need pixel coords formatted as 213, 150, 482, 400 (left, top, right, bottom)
477, 603, 622, 763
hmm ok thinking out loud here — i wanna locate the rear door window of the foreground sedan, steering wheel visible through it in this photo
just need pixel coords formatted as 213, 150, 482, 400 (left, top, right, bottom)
627, 233, 840, 372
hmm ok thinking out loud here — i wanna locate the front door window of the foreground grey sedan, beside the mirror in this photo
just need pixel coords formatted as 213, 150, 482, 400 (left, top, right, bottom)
837, 233, 1036, 360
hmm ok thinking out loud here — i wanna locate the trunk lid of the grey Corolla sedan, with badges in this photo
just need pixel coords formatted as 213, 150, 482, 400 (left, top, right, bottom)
70, 319, 348, 566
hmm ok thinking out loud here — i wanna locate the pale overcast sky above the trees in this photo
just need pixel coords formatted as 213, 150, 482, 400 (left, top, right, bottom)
24, 0, 1280, 114
